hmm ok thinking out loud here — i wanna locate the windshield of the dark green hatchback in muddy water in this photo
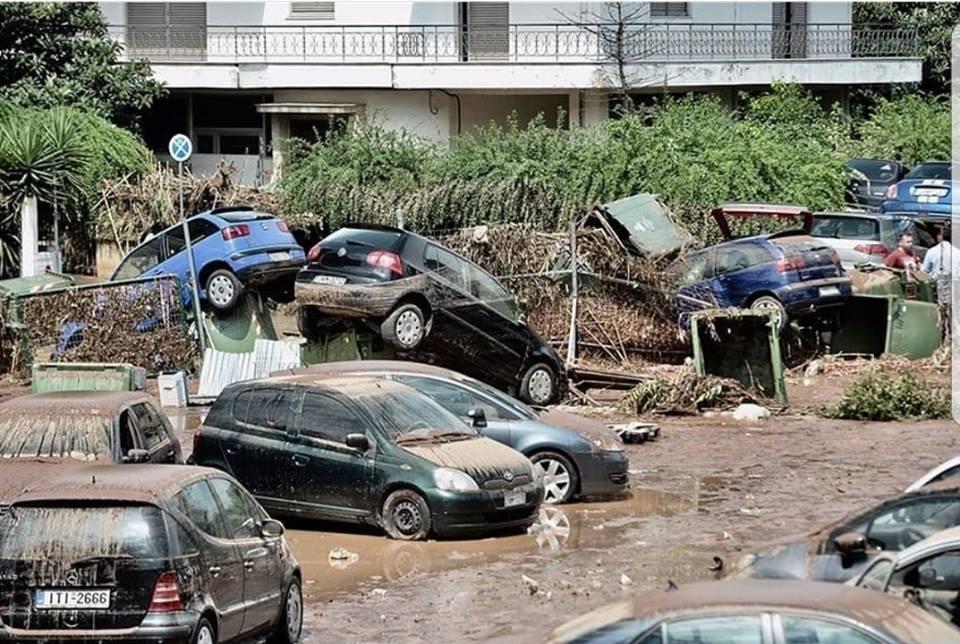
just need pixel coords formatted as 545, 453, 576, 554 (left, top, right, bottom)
356, 387, 477, 445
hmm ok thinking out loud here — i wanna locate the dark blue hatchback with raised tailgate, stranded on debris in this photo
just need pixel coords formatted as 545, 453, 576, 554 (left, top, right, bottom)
673, 204, 851, 328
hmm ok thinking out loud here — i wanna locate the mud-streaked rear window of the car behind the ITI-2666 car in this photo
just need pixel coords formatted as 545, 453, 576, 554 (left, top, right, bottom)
0, 412, 112, 461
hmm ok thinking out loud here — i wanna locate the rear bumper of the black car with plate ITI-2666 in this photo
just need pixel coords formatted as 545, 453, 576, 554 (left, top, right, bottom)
0, 611, 200, 644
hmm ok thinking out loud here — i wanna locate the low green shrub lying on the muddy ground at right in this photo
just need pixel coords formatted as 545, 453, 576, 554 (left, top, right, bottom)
827, 371, 950, 421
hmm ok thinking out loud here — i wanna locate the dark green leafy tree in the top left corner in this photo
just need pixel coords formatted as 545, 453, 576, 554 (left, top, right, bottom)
0, 2, 165, 127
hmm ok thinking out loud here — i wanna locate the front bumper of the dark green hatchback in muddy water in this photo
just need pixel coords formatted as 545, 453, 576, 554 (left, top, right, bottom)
427, 483, 543, 535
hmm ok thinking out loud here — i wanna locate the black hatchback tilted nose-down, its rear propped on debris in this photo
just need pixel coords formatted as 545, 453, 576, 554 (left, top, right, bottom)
296, 224, 565, 405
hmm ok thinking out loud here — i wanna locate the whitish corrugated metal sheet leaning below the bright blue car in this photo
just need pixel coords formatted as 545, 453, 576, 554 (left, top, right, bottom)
197, 340, 301, 398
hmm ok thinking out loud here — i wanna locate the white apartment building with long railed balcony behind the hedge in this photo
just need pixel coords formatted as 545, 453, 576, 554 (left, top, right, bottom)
101, 1, 921, 183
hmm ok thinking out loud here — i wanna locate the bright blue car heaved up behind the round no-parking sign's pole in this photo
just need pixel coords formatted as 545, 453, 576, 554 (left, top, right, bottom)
110, 206, 306, 314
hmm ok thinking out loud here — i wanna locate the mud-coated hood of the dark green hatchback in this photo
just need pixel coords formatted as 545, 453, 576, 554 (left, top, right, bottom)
400, 438, 533, 485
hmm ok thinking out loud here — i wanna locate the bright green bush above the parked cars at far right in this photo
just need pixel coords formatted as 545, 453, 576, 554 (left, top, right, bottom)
854, 95, 951, 166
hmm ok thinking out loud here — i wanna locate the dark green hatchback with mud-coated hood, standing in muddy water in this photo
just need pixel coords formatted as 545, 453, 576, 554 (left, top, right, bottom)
191, 374, 544, 540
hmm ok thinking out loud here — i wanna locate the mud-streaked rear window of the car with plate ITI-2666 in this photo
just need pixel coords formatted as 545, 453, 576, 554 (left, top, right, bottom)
0, 505, 168, 564
